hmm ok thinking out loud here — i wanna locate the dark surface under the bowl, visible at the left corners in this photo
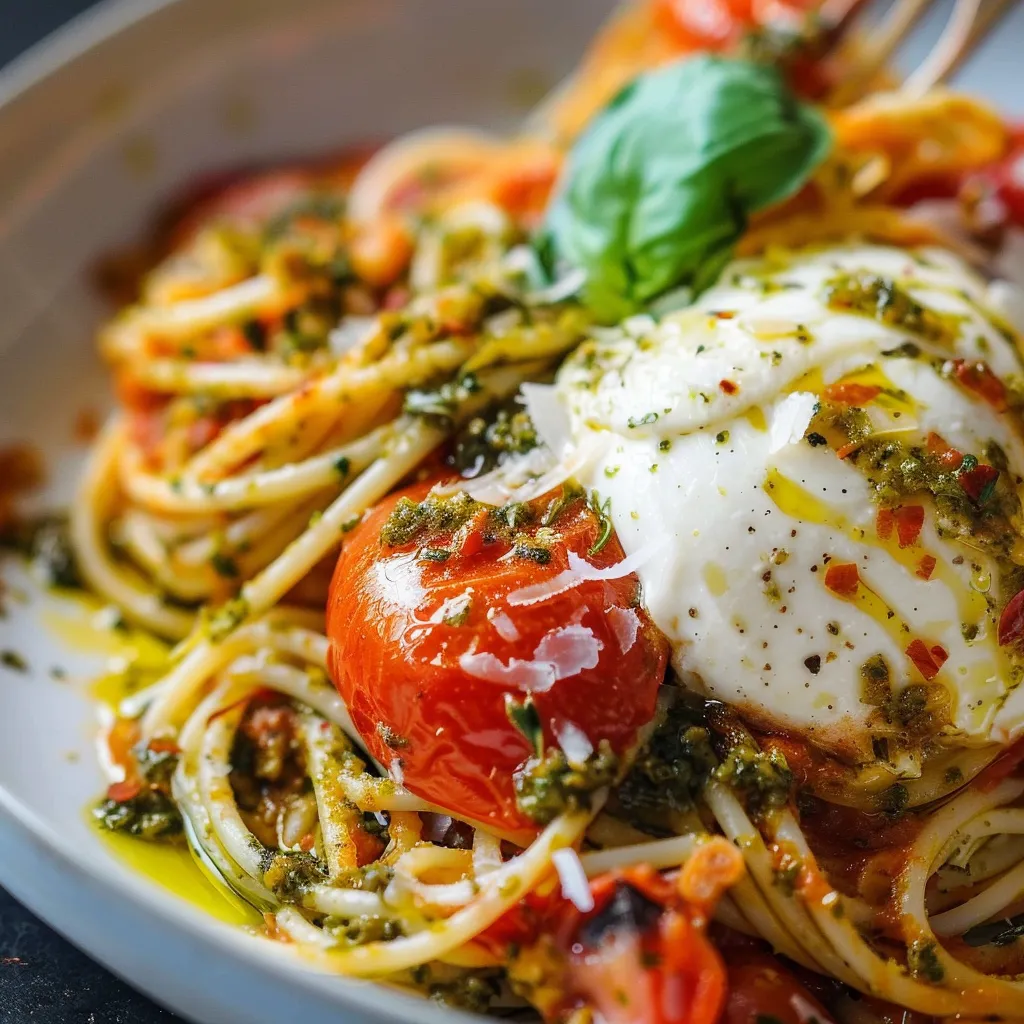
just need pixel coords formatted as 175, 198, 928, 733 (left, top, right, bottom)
0, 8, 179, 1024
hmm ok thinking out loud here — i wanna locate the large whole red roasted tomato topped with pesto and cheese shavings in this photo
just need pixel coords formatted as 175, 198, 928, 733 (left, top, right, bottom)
328, 484, 668, 834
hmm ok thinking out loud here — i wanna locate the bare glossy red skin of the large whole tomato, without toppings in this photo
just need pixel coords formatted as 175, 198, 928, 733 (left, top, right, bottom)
328, 483, 668, 834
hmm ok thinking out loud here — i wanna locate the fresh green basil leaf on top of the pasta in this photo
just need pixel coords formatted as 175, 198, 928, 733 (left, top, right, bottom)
538, 55, 833, 321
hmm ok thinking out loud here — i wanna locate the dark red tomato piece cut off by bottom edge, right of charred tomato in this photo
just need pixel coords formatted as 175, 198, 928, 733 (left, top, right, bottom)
720, 953, 833, 1024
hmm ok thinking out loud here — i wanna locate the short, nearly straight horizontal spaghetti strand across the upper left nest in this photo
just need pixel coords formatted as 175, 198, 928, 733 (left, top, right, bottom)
132, 358, 309, 401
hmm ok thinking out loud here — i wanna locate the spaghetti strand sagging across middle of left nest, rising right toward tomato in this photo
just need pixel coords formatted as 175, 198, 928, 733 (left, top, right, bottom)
121, 425, 394, 513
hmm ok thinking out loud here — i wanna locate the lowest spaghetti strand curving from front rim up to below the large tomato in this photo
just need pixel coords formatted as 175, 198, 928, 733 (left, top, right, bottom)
294, 812, 591, 978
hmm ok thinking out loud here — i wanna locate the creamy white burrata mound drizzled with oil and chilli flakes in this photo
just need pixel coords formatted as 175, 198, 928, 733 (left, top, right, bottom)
529, 246, 1024, 761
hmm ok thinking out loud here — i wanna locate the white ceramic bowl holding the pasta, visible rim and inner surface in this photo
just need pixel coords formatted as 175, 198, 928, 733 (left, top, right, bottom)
0, 0, 1024, 1024
